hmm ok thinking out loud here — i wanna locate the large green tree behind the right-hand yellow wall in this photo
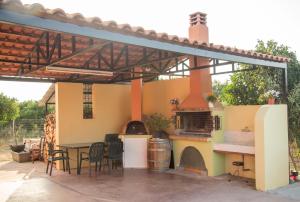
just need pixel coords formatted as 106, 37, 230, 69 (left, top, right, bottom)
220, 40, 300, 105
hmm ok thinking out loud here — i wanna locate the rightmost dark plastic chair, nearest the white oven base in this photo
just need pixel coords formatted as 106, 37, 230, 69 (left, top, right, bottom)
106, 141, 124, 173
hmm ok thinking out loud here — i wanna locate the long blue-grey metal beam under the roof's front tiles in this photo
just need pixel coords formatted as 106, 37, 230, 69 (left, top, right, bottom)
0, 9, 287, 69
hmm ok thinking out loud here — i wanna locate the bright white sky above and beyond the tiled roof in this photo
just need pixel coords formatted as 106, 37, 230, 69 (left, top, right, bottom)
0, 0, 300, 101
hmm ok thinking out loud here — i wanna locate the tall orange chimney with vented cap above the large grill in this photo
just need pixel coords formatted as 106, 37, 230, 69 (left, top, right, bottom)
180, 12, 212, 111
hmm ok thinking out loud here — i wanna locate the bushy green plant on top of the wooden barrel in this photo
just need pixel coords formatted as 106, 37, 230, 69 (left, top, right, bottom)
145, 113, 172, 134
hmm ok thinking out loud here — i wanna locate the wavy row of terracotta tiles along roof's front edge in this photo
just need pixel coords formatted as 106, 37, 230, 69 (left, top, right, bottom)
0, 0, 289, 62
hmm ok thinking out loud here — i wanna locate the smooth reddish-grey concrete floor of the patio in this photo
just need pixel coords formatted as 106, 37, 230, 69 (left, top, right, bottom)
0, 161, 300, 202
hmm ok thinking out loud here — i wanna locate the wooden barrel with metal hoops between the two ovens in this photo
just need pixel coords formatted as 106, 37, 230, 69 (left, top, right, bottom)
148, 138, 171, 171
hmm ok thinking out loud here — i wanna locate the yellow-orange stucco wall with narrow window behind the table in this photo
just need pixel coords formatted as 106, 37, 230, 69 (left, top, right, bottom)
55, 83, 131, 168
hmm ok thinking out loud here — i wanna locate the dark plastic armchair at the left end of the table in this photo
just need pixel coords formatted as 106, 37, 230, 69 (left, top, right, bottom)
46, 142, 71, 176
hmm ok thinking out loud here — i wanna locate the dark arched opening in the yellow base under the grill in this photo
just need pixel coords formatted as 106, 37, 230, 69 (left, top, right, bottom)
179, 146, 207, 175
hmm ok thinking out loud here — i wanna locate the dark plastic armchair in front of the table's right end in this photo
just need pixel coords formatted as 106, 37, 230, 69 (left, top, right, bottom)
79, 142, 104, 176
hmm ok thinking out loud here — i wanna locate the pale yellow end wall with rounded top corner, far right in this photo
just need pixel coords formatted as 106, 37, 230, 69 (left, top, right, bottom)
255, 105, 289, 191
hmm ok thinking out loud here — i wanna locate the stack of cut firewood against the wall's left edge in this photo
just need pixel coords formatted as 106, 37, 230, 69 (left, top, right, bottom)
44, 114, 56, 161
